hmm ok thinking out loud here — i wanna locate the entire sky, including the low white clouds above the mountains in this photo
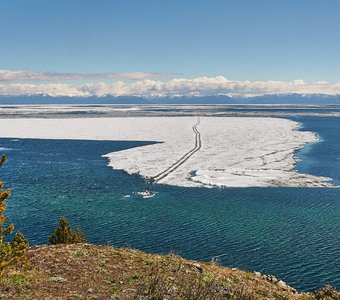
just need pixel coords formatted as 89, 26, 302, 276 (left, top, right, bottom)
0, 0, 340, 96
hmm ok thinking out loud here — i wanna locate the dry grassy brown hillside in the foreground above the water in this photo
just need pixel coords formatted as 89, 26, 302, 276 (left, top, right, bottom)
0, 244, 340, 300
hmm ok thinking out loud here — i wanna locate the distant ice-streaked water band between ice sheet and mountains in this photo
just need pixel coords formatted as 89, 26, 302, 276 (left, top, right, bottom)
0, 104, 340, 119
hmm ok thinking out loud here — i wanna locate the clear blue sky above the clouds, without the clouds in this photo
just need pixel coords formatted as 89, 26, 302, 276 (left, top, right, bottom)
0, 0, 340, 81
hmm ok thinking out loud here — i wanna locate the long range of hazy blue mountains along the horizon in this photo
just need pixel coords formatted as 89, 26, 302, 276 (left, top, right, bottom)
0, 94, 340, 105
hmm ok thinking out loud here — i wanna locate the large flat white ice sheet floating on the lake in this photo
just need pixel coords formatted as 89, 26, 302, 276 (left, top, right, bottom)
0, 117, 331, 187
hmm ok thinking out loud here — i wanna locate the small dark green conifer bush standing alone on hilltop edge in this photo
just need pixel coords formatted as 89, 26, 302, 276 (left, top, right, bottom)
48, 217, 86, 245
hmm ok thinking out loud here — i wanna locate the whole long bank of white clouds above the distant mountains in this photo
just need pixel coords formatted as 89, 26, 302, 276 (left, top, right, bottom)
0, 71, 340, 98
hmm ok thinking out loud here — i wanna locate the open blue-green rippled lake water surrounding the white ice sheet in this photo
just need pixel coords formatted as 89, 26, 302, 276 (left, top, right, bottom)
0, 117, 340, 290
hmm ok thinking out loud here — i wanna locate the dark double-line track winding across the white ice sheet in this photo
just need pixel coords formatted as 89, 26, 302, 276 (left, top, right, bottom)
147, 117, 202, 183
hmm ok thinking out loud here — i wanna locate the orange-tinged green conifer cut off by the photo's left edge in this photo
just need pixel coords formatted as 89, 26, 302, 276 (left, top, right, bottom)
0, 155, 28, 276
